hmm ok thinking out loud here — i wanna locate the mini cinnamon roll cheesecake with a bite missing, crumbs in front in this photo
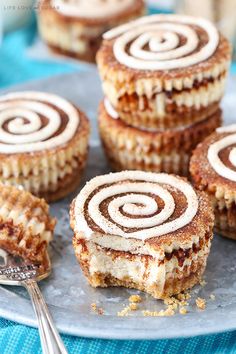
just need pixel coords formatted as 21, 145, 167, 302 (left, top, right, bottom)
70, 171, 214, 298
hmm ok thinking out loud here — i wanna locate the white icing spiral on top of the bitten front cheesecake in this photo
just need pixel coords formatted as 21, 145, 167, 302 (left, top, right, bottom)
74, 171, 198, 240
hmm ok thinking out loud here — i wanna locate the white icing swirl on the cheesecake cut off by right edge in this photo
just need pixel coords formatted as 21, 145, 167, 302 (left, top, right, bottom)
207, 124, 236, 182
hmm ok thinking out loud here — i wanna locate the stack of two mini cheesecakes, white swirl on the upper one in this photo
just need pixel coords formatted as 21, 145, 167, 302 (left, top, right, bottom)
97, 15, 230, 175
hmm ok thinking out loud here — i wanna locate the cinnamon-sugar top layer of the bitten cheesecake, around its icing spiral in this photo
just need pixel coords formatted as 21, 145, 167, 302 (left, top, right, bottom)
70, 176, 214, 250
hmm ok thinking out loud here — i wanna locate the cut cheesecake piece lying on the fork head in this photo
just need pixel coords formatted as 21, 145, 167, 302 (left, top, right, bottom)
0, 184, 56, 269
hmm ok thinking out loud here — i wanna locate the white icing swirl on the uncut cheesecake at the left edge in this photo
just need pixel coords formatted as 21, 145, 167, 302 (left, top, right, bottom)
0, 91, 80, 154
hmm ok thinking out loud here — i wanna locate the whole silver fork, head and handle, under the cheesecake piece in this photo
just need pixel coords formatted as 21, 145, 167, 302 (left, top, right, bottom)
0, 248, 67, 354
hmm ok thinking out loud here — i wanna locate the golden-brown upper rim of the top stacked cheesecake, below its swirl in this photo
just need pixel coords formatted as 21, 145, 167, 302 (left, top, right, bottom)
97, 30, 231, 82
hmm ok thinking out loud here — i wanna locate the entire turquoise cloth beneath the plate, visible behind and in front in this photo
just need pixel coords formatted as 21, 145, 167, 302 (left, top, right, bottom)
0, 13, 236, 354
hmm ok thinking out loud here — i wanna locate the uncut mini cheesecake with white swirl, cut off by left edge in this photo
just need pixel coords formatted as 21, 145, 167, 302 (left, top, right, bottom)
0, 91, 89, 201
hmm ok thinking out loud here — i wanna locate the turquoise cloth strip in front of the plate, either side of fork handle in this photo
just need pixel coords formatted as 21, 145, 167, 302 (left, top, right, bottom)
0, 314, 236, 354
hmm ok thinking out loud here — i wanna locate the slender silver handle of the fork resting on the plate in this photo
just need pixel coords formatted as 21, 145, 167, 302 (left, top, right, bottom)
23, 279, 68, 354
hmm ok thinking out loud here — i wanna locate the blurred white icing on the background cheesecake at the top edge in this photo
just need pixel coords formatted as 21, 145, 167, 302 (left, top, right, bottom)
51, 0, 135, 18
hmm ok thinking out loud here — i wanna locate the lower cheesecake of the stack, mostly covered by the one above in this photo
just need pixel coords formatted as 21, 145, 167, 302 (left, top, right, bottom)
98, 99, 221, 176
